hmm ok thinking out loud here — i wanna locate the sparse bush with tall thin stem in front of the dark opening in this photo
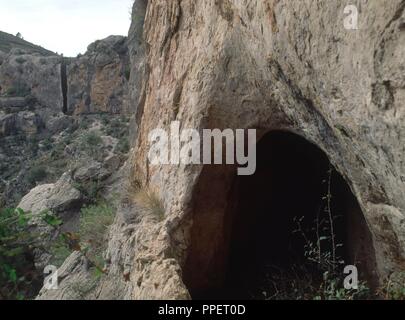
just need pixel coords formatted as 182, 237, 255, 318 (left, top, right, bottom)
252, 169, 374, 300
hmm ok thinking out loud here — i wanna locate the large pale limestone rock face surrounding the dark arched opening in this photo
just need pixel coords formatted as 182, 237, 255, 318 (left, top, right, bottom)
123, 0, 405, 299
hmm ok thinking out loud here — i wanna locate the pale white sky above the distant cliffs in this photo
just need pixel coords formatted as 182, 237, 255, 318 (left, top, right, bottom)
0, 0, 134, 57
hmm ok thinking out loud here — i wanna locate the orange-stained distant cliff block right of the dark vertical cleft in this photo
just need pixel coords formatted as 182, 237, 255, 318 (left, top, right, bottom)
67, 36, 131, 114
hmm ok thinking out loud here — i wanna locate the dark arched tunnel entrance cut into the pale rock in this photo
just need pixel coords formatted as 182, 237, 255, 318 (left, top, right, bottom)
183, 132, 375, 299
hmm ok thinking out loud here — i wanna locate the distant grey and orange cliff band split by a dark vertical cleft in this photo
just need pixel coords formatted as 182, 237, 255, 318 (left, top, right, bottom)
0, 36, 131, 115
